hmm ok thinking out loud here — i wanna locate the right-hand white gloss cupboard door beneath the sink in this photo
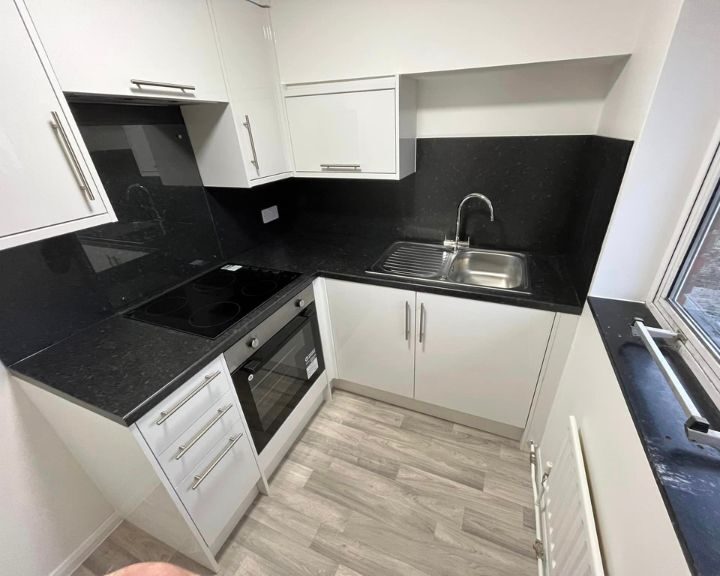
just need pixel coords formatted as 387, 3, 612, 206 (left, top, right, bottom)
415, 293, 555, 428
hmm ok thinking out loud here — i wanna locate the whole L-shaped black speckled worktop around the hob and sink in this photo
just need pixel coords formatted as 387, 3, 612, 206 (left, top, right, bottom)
10, 234, 582, 425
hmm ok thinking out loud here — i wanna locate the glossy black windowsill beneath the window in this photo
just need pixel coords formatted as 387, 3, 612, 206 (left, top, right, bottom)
588, 297, 720, 575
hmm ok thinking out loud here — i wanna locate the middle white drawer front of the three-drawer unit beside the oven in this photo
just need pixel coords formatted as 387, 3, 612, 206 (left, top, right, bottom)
158, 391, 240, 486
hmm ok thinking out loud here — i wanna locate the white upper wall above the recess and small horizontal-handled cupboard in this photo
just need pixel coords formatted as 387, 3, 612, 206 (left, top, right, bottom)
271, 0, 654, 83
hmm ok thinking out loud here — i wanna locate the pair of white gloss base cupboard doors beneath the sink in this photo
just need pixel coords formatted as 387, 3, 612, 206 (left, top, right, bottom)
326, 280, 555, 433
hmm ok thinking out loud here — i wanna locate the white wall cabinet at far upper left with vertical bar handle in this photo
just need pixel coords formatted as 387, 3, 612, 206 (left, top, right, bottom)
0, 0, 115, 249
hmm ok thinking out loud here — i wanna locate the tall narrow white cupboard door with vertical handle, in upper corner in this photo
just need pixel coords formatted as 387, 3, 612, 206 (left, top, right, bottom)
211, 0, 291, 180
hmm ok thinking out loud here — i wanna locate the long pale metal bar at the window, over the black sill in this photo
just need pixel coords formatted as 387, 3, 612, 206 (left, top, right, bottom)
632, 319, 720, 449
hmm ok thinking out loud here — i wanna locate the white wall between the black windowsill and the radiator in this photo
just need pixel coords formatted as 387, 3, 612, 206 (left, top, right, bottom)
540, 306, 690, 576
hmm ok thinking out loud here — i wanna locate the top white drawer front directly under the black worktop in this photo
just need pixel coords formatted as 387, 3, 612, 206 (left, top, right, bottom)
138, 358, 232, 455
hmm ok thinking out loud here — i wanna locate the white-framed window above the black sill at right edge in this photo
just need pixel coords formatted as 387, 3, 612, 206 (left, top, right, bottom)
652, 141, 720, 405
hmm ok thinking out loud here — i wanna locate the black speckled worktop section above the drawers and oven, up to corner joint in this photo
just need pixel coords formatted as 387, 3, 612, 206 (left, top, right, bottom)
10, 275, 313, 426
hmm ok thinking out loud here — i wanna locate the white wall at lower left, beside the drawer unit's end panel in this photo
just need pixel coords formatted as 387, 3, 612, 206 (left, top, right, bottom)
0, 364, 114, 576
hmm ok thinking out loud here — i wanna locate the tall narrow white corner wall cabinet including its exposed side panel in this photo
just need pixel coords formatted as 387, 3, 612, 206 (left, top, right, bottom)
183, 0, 292, 188
